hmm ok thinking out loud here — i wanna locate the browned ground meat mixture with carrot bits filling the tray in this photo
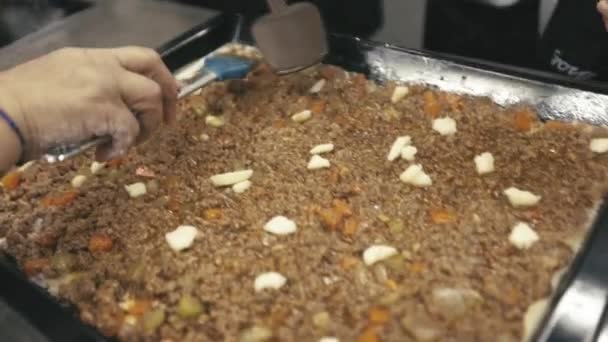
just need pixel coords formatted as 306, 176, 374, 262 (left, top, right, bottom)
0, 62, 608, 342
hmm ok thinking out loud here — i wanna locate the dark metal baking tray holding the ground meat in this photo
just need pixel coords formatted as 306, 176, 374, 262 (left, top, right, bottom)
0, 15, 608, 342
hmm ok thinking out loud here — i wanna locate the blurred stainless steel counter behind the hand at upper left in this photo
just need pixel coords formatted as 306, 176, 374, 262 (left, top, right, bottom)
0, 0, 217, 70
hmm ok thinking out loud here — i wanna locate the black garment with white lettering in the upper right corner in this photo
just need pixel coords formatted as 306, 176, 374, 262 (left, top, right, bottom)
538, 0, 608, 81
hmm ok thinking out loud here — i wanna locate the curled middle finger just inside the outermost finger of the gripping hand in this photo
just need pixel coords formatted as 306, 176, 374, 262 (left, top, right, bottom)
118, 72, 163, 143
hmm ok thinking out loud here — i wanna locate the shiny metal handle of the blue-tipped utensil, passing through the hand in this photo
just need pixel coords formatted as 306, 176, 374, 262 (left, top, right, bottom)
42, 72, 217, 163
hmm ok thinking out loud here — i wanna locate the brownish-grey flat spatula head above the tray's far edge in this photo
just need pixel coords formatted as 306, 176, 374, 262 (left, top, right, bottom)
252, 2, 328, 74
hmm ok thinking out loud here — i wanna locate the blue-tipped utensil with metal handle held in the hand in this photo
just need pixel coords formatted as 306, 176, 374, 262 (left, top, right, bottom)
42, 55, 253, 163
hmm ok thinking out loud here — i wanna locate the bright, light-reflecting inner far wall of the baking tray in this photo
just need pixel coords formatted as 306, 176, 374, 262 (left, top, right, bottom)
338, 38, 608, 125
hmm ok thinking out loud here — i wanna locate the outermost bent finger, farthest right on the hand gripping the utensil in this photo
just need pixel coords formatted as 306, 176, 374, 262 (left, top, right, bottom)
112, 47, 178, 123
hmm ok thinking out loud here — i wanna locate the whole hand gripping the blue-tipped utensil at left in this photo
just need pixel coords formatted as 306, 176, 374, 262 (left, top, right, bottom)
0, 47, 178, 160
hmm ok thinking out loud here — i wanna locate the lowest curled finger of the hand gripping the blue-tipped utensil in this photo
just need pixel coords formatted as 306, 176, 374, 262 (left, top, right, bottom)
95, 106, 139, 161
